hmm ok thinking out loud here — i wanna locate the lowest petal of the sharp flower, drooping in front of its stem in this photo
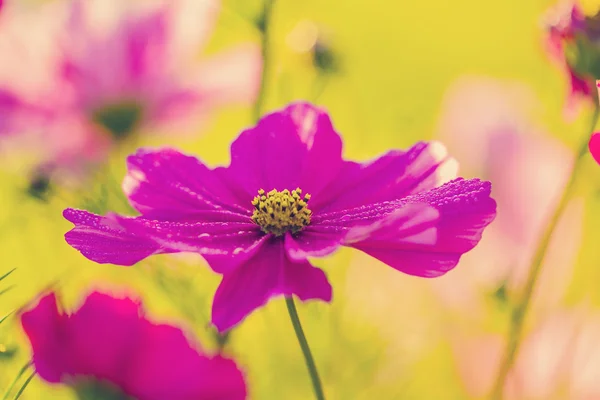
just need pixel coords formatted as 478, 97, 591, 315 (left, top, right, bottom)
212, 239, 331, 332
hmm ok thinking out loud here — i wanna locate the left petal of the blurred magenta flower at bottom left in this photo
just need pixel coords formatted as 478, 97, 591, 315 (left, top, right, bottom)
21, 293, 144, 386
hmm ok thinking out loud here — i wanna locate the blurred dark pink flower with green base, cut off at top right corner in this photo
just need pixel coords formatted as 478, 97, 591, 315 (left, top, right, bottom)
544, 1, 600, 115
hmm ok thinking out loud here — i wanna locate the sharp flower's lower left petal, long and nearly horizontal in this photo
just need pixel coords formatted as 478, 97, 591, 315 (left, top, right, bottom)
64, 209, 268, 272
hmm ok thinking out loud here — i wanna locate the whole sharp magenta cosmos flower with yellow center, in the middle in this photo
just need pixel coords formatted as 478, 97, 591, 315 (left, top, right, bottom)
64, 103, 496, 331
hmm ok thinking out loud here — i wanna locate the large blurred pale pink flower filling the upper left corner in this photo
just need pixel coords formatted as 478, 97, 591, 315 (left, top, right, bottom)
0, 0, 261, 178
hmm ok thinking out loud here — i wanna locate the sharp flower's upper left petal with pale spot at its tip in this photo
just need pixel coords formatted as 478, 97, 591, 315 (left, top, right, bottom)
123, 149, 252, 219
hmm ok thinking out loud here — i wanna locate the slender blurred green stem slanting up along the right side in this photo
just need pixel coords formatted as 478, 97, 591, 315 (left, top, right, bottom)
491, 107, 600, 400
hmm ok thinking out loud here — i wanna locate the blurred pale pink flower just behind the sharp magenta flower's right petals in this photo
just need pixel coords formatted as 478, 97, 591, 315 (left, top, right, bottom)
433, 77, 583, 316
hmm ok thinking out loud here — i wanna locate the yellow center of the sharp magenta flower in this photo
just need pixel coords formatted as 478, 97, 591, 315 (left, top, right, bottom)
252, 188, 312, 236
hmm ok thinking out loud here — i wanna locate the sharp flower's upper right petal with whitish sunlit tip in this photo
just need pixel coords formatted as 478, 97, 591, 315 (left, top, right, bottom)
311, 142, 457, 213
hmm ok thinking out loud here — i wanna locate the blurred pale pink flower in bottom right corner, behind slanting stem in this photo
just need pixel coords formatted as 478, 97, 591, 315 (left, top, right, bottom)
455, 310, 600, 400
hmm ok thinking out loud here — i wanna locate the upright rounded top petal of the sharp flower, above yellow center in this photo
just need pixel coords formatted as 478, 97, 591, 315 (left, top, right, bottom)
223, 103, 342, 203
